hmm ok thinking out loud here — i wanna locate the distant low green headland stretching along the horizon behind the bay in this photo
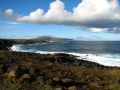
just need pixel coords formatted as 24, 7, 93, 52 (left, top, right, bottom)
0, 36, 72, 50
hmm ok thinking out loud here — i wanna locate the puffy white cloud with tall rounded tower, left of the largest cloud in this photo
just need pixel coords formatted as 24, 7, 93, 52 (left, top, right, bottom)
17, 0, 71, 24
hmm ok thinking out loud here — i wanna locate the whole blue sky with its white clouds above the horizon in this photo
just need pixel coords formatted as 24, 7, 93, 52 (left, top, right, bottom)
0, 0, 120, 41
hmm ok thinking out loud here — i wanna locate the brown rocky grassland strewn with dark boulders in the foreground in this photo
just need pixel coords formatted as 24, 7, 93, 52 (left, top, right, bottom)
0, 51, 120, 90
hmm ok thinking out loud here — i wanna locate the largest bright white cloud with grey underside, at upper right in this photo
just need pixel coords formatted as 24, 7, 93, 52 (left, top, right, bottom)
73, 0, 120, 28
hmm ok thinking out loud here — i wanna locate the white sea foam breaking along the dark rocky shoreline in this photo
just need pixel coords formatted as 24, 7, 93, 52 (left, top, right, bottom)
10, 45, 120, 66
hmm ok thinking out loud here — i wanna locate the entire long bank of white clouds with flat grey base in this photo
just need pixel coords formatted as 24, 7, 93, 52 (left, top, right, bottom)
2, 0, 120, 32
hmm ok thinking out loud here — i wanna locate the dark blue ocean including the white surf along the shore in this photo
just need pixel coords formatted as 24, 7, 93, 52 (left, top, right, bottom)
11, 40, 120, 66
